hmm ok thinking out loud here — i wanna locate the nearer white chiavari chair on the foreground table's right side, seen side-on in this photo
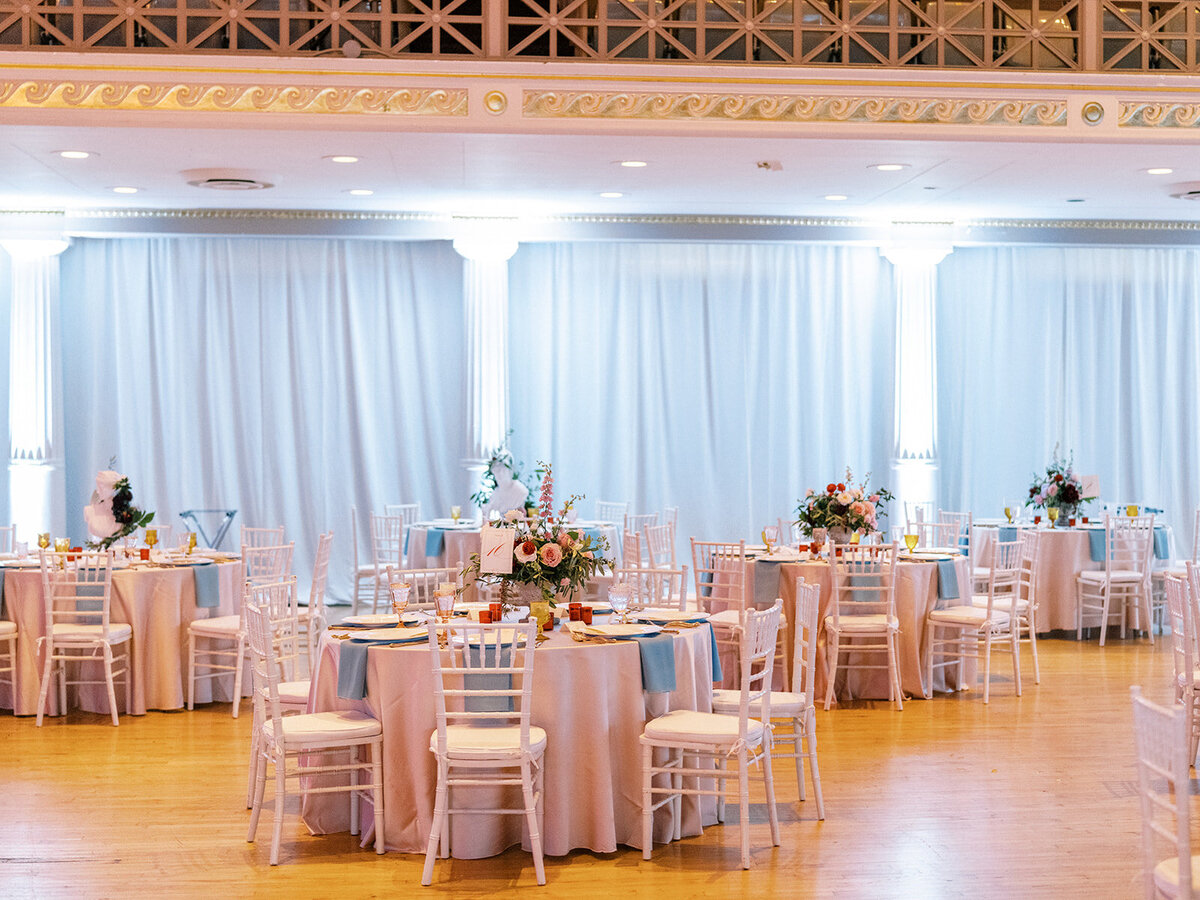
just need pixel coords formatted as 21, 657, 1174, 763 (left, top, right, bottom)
641, 600, 782, 869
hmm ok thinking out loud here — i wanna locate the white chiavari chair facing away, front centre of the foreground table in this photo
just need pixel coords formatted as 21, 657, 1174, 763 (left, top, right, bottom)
421, 622, 546, 884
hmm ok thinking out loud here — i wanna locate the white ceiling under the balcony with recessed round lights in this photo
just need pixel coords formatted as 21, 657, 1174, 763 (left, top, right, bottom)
0, 124, 1200, 221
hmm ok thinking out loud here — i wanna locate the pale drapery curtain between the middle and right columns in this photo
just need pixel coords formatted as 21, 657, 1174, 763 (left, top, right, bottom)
509, 242, 894, 552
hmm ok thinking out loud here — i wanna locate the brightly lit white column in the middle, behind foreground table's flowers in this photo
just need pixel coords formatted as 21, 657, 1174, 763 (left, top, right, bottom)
454, 235, 517, 511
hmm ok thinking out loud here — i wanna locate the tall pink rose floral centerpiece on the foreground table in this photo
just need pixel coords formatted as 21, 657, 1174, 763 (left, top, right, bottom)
462, 463, 611, 628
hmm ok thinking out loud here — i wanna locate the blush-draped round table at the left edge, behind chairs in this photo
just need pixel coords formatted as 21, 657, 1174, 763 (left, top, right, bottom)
0, 562, 242, 715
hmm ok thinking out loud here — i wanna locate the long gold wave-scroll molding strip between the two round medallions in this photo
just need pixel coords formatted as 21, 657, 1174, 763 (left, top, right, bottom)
522, 90, 1067, 126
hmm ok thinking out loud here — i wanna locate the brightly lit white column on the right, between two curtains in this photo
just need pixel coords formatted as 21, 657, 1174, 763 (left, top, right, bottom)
882, 244, 952, 524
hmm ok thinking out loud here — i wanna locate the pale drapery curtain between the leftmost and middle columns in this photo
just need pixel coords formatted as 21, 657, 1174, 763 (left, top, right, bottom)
61, 238, 469, 596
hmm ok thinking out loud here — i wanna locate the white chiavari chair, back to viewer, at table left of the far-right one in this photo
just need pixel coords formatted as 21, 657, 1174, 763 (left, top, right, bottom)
824, 544, 904, 709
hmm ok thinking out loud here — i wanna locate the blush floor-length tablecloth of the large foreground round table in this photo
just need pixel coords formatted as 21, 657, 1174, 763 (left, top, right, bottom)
302, 626, 716, 859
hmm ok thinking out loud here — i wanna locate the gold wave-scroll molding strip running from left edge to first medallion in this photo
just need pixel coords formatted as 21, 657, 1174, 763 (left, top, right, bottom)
0, 80, 467, 116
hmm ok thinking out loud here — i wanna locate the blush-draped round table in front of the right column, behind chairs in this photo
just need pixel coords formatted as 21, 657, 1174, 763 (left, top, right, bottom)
721, 557, 976, 703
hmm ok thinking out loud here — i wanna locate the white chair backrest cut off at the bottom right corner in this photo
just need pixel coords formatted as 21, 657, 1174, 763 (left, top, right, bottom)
1129, 685, 1192, 898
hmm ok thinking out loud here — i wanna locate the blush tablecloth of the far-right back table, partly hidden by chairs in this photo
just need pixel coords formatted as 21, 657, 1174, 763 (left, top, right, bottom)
971, 526, 1171, 634
